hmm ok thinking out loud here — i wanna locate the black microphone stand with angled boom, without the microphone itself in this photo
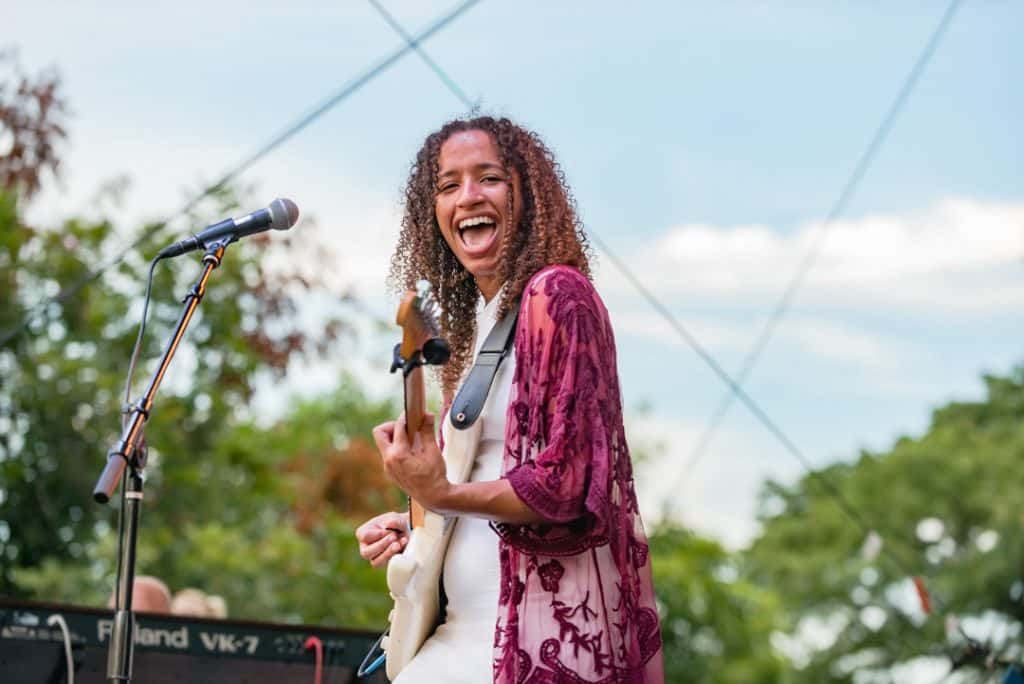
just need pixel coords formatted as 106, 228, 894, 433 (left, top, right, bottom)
92, 236, 236, 684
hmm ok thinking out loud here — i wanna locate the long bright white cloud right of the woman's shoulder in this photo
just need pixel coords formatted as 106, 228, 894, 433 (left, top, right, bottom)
607, 199, 1024, 315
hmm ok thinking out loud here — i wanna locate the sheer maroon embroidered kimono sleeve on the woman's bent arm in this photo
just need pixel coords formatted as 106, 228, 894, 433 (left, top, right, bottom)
499, 267, 628, 550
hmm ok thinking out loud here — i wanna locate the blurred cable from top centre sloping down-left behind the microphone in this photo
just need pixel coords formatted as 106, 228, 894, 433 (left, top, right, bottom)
0, 0, 479, 348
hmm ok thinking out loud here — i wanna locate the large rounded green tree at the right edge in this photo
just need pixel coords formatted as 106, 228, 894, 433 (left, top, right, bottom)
749, 369, 1024, 682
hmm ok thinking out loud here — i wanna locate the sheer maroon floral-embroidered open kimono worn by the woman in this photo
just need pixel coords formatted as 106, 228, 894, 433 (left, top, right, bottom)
493, 266, 665, 684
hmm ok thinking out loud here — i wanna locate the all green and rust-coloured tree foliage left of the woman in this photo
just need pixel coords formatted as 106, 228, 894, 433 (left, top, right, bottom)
0, 56, 409, 625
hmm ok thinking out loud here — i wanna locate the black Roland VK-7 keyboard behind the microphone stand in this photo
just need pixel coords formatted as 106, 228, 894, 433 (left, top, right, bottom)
0, 599, 387, 684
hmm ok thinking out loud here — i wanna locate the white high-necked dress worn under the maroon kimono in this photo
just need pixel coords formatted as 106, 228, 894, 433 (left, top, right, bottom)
394, 296, 515, 684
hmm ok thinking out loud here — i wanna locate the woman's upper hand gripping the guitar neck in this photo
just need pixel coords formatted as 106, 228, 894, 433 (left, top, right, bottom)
374, 414, 452, 511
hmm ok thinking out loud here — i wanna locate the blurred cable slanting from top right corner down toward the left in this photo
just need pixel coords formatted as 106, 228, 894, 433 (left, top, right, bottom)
673, 0, 961, 499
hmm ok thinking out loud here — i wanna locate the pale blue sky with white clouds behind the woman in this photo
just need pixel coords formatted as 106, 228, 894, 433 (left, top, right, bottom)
9, 0, 1024, 548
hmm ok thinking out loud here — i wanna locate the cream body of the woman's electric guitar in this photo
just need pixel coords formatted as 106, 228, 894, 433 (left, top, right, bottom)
381, 420, 482, 680
